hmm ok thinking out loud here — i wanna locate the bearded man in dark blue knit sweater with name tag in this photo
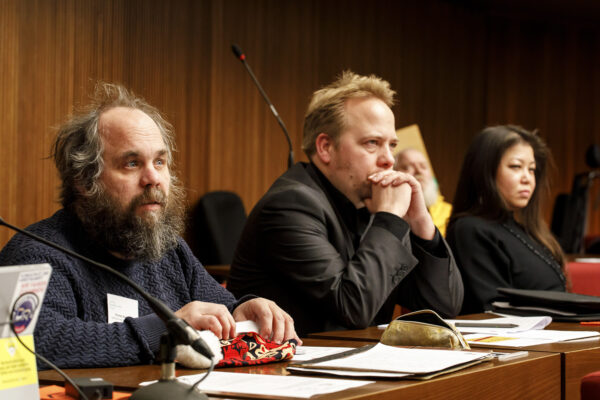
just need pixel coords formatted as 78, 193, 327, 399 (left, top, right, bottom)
0, 83, 297, 368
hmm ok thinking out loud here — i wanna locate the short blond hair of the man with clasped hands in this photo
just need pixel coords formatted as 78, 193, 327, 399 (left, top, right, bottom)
302, 71, 396, 158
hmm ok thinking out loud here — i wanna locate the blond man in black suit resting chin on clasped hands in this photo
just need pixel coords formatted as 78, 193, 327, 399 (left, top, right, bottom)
228, 71, 463, 335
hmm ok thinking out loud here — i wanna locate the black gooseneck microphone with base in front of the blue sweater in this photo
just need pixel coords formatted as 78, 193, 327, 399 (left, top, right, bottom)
0, 217, 213, 400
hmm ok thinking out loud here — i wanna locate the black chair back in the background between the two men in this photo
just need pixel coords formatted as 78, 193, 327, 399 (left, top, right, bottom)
190, 191, 246, 265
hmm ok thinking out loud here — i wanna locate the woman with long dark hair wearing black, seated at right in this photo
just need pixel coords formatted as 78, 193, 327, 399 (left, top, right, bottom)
447, 125, 566, 314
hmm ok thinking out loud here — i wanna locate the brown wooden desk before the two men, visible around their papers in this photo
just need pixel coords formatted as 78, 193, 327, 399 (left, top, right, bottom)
39, 338, 561, 400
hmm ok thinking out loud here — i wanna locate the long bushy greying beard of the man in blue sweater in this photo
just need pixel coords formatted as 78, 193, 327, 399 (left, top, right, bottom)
75, 179, 184, 261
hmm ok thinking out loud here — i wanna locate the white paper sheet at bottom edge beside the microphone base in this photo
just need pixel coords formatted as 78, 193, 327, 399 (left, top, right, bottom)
140, 371, 374, 399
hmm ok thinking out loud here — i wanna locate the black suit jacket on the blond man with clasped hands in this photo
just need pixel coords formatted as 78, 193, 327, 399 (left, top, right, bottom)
227, 163, 463, 335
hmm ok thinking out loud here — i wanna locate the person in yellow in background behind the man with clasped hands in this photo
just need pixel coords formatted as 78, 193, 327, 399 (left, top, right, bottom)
394, 148, 452, 236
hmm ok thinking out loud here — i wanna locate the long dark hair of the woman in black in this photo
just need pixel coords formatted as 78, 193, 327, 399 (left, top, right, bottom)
448, 125, 564, 266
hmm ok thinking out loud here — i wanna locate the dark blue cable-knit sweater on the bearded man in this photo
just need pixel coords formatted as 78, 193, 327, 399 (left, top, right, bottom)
0, 210, 244, 369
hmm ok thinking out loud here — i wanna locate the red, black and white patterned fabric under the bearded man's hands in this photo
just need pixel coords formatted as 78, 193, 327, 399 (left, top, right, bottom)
217, 332, 297, 367
